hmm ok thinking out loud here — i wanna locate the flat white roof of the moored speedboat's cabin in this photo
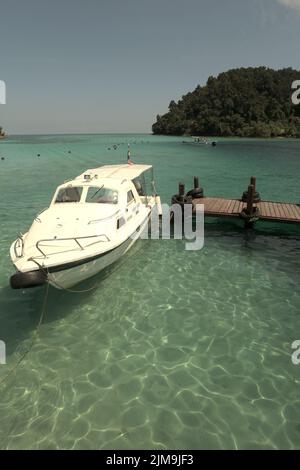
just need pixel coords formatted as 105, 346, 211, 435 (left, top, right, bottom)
75, 163, 152, 180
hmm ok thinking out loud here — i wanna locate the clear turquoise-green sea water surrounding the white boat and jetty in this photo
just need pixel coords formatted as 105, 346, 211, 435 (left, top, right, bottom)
0, 135, 300, 449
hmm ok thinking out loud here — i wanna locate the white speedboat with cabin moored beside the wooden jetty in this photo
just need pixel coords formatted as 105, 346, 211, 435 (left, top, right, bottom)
10, 164, 161, 289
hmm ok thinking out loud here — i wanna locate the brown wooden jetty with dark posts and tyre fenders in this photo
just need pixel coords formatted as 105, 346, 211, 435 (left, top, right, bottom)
172, 176, 300, 227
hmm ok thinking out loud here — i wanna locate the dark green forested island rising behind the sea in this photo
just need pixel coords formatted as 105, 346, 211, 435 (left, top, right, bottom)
152, 67, 300, 137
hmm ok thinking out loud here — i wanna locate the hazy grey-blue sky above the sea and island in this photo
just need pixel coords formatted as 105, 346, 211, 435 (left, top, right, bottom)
0, 0, 300, 134
